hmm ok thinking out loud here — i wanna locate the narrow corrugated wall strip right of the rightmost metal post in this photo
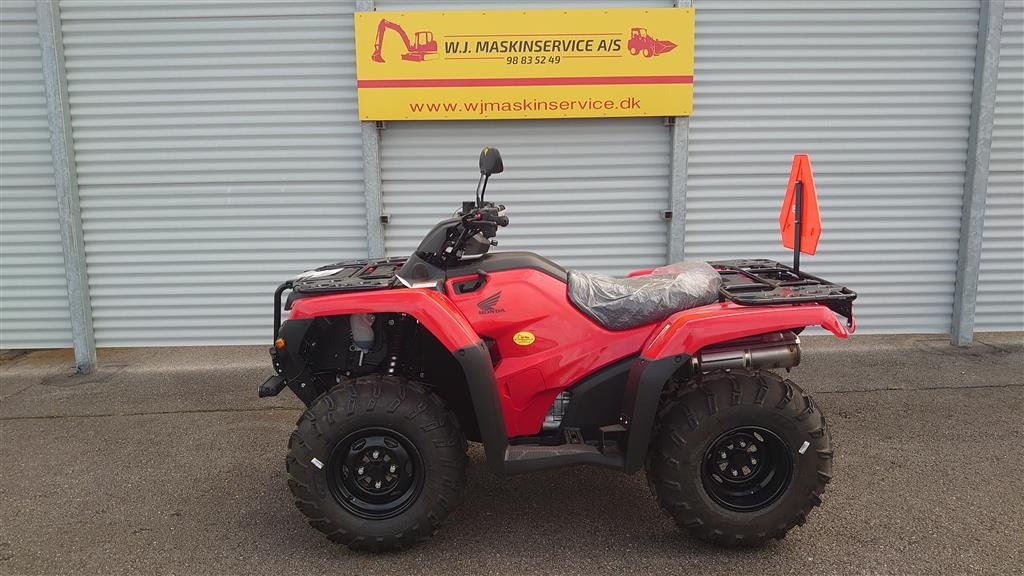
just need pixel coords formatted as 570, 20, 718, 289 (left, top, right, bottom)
975, 2, 1024, 330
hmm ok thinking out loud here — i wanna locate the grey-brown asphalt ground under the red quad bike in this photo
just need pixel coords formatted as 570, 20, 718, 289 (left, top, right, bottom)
0, 333, 1024, 576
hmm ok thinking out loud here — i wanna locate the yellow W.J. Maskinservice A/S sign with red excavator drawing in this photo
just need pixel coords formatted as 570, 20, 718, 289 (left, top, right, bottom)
355, 8, 694, 120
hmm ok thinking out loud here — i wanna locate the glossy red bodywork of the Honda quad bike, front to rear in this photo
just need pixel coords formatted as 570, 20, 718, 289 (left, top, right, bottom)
291, 269, 854, 438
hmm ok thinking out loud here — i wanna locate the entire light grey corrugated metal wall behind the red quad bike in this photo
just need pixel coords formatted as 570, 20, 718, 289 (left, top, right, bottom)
0, 0, 1024, 348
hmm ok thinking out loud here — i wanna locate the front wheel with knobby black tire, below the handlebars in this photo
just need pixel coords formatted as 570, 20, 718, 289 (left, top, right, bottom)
286, 375, 467, 550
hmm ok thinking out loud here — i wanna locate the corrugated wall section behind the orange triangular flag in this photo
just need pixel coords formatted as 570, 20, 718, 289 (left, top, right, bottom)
686, 0, 979, 332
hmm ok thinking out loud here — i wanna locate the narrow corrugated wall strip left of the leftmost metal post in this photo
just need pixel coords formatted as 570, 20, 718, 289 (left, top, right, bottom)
0, 0, 71, 349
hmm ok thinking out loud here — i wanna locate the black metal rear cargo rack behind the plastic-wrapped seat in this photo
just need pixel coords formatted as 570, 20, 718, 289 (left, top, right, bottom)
708, 259, 857, 326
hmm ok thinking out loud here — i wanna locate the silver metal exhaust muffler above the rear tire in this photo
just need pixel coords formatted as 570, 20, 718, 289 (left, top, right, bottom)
692, 330, 800, 374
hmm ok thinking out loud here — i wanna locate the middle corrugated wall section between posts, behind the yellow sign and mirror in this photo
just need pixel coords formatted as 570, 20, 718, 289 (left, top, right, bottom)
376, 1, 672, 274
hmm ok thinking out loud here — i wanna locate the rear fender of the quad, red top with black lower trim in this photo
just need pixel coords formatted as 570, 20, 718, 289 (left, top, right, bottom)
622, 302, 853, 472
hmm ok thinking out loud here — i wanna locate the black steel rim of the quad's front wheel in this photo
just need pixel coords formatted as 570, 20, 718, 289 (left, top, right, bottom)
327, 428, 424, 520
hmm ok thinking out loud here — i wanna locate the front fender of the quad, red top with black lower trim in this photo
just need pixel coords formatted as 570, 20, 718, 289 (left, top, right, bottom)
283, 288, 508, 474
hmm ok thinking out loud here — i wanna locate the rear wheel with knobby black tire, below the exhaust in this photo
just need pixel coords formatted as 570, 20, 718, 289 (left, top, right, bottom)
646, 370, 833, 545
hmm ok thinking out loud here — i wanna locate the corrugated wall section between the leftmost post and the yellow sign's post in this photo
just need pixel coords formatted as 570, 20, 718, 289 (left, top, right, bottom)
60, 0, 367, 345
